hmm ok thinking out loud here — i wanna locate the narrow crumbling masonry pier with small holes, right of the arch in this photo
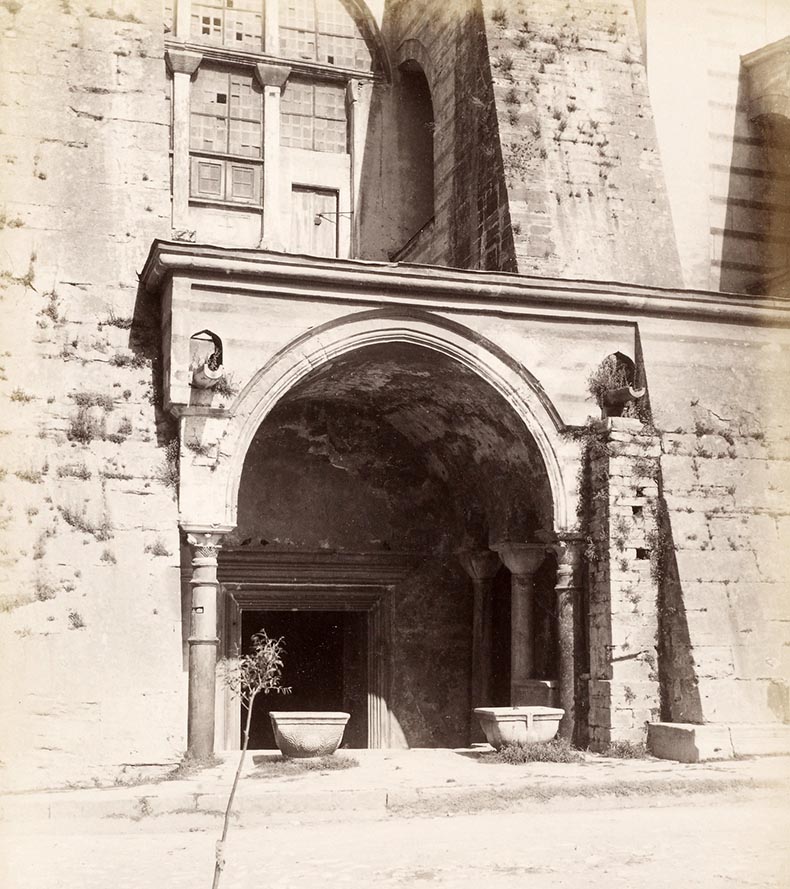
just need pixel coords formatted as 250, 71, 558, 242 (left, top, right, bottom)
584, 418, 660, 750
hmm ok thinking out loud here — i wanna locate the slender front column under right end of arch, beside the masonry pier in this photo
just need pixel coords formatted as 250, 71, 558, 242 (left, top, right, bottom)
553, 534, 584, 741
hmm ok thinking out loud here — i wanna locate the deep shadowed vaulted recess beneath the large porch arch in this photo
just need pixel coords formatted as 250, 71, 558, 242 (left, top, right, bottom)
220, 338, 556, 747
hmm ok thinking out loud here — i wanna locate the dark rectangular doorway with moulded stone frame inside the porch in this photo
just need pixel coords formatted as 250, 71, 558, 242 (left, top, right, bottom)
216, 549, 406, 750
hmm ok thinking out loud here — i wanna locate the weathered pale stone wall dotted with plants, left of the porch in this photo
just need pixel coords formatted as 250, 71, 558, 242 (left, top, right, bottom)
0, 0, 185, 781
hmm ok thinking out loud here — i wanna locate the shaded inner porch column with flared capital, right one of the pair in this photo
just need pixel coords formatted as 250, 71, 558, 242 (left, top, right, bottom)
493, 542, 546, 707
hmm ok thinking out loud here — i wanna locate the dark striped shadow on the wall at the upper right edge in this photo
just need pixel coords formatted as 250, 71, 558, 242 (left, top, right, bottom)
711, 69, 790, 293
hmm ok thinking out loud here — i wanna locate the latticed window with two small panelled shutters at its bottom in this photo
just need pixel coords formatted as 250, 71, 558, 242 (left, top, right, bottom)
190, 67, 263, 204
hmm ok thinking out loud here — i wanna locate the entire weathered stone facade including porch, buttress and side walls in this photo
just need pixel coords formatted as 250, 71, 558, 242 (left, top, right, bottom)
0, 0, 790, 780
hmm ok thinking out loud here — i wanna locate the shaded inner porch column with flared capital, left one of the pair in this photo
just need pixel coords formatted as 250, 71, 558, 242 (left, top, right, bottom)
458, 549, 500, 709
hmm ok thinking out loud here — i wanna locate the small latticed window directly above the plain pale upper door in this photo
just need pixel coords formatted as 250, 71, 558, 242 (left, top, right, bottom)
280, 78, 348, 153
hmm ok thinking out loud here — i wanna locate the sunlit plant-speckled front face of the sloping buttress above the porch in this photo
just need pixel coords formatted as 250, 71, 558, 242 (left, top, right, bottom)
484, 0, 680, 286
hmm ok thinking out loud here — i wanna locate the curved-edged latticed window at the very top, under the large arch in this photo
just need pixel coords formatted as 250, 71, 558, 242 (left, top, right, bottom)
279, 0, 373, 71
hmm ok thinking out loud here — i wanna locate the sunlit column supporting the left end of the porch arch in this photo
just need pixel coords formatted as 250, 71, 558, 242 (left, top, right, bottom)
184, 528, 230, 758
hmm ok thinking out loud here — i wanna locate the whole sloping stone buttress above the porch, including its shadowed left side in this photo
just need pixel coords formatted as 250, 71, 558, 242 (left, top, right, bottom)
384, 0, 680, 286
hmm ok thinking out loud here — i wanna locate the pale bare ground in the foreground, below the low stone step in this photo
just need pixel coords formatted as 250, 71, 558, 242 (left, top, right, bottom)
0, 791, 790, 889
